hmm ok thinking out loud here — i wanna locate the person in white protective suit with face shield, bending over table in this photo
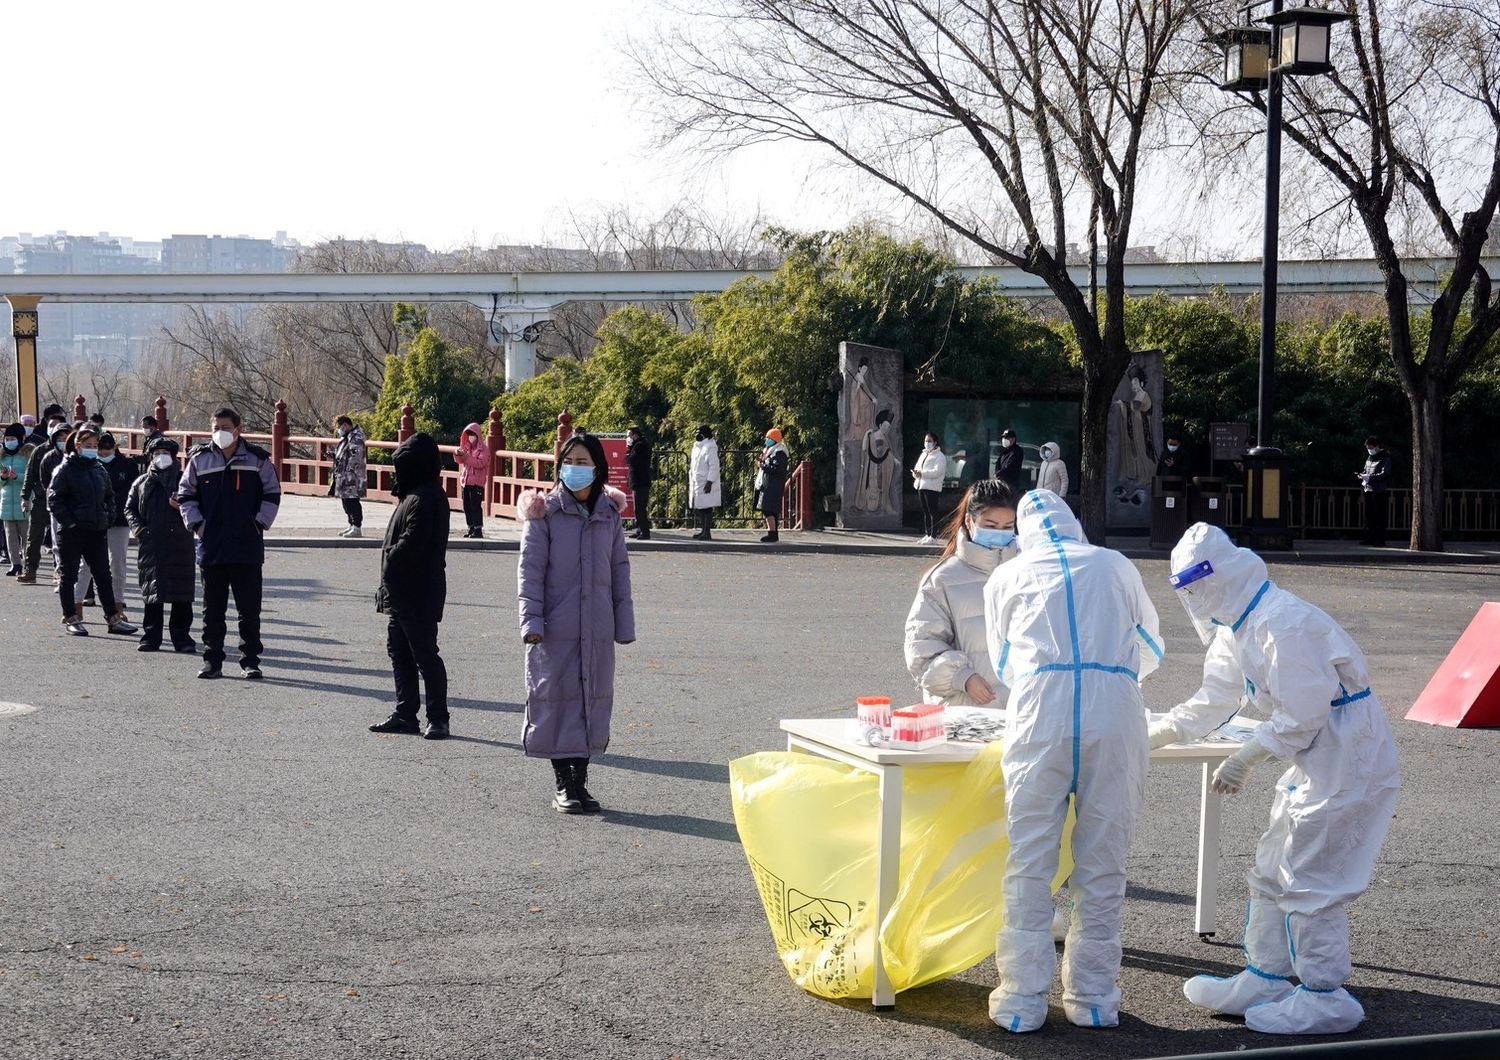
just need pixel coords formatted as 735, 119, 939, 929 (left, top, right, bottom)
1151, 523, 1400, 1035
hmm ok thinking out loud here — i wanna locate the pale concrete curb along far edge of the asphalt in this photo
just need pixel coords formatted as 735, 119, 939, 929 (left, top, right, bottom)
266, 534, 1500, 567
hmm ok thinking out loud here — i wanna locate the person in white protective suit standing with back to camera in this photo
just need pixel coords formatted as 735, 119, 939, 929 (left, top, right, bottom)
984, 490, 1163, 1033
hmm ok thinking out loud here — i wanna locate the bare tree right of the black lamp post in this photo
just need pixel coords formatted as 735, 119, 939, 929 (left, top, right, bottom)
1211, 0, 1500, 550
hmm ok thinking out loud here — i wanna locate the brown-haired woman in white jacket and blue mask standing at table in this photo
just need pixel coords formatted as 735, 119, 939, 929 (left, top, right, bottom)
906, 478, 1016, 706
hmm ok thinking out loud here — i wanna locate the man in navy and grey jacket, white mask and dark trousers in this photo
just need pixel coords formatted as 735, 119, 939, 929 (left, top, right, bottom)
177, 408, 281, 681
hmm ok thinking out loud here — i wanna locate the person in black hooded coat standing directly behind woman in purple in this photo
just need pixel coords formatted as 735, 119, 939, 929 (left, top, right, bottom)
371, 433, 449, 739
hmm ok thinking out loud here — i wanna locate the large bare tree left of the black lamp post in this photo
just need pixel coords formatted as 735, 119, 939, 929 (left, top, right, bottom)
635, 0, 1200, 537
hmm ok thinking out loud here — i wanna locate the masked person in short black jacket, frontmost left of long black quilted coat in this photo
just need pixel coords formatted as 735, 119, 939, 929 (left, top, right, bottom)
47, 423, 135, 637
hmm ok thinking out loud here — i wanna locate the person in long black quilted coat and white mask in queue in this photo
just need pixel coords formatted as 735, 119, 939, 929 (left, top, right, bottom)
125, 435, 198, 654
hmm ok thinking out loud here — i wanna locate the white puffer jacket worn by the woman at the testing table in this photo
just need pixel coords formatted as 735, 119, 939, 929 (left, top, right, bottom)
906, 529, 1016, 706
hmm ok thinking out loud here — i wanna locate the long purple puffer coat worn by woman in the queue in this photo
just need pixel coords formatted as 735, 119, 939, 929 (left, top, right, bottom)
516, 486, 636, 759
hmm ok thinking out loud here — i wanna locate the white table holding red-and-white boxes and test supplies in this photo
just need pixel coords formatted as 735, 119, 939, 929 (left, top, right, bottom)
782, 708, 1257, 1009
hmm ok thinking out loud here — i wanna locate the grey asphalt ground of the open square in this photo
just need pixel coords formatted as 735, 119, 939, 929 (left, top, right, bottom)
0, 549, 1500, 1060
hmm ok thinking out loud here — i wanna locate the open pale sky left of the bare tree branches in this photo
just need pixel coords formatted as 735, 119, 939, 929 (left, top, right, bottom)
0, 0, 860, 247
